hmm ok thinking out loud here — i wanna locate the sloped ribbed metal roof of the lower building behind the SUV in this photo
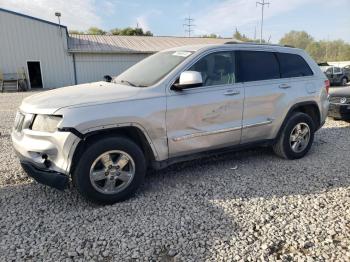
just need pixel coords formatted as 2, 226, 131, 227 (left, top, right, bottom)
69, 34, 233, 53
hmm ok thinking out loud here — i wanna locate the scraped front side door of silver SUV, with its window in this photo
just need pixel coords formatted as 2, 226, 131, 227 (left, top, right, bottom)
166, 51, 244, 157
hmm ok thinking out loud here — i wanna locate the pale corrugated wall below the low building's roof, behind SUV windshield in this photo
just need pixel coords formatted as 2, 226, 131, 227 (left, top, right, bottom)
75, 53, 149, 84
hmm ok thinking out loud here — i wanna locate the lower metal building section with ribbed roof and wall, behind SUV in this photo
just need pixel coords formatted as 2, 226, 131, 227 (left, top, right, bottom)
69, 35, 228, 83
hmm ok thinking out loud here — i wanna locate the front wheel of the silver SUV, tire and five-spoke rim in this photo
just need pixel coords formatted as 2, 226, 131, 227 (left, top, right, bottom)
73, 137, 146, 204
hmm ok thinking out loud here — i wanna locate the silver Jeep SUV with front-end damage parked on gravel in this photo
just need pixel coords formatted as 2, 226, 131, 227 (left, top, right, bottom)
12, 43, 329, 204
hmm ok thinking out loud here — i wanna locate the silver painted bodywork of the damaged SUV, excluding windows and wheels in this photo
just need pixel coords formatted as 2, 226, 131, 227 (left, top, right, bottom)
12, 44, 329, 174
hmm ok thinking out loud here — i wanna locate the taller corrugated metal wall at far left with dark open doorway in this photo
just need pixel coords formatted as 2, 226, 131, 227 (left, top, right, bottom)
0, 10, 74, 88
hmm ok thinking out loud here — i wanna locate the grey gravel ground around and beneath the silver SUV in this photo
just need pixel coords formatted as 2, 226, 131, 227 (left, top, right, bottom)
0, 93, 350, 261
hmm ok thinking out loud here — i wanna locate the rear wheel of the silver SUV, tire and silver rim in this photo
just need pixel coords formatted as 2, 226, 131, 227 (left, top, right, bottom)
273, 112, 315, 160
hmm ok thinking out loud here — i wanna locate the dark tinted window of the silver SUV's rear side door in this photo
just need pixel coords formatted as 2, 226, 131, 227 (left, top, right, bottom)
238, 51, 280, 82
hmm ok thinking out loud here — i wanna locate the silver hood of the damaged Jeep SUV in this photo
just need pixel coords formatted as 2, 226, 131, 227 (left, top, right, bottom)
20, 81, 141, 114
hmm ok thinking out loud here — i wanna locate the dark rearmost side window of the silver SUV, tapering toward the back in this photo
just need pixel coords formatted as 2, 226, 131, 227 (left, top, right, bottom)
277, 53, 313, 78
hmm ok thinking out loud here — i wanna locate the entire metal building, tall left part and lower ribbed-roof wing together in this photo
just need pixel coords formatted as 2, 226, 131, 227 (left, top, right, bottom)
0, 8, 232, 88
